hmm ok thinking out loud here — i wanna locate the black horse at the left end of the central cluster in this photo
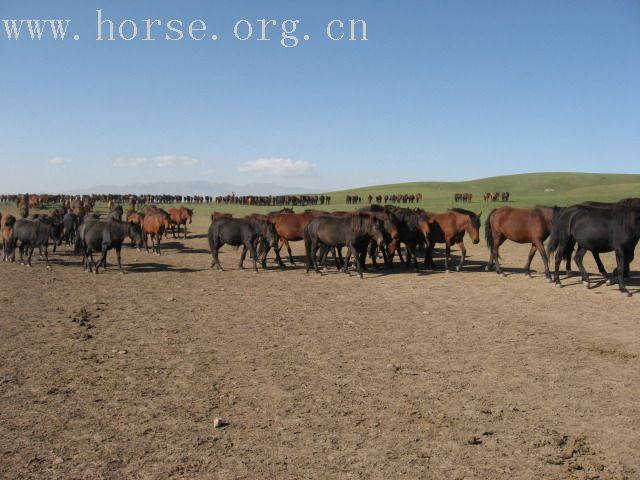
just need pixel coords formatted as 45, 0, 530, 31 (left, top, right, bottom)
207, 217, 275, 272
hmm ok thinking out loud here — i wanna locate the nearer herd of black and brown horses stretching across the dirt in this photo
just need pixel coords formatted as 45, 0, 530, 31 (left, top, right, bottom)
0, 198, 640, 296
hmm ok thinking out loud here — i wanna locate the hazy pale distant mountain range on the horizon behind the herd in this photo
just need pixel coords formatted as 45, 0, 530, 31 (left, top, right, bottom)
66, 181, 321, 196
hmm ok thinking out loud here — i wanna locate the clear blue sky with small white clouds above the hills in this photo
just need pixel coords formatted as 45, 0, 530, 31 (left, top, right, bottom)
0, 0, 640, 191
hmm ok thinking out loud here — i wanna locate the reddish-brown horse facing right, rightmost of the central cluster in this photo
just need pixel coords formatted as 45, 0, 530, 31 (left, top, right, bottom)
424, 208, 482, 273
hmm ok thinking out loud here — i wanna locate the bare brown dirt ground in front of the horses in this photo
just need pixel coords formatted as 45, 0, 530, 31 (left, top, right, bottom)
0, 226, 640, 479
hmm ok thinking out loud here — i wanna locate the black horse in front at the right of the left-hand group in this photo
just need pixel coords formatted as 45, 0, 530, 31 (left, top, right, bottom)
75, 219, 144, 274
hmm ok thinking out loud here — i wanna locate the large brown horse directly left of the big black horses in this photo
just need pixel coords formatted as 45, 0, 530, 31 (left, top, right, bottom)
484, 207, 553, 282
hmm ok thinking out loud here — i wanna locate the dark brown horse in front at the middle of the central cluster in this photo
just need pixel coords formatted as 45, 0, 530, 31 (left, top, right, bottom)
304, 213, 384, 278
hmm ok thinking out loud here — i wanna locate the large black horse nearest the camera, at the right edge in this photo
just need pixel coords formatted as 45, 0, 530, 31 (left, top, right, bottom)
548, 204, 640, 297
